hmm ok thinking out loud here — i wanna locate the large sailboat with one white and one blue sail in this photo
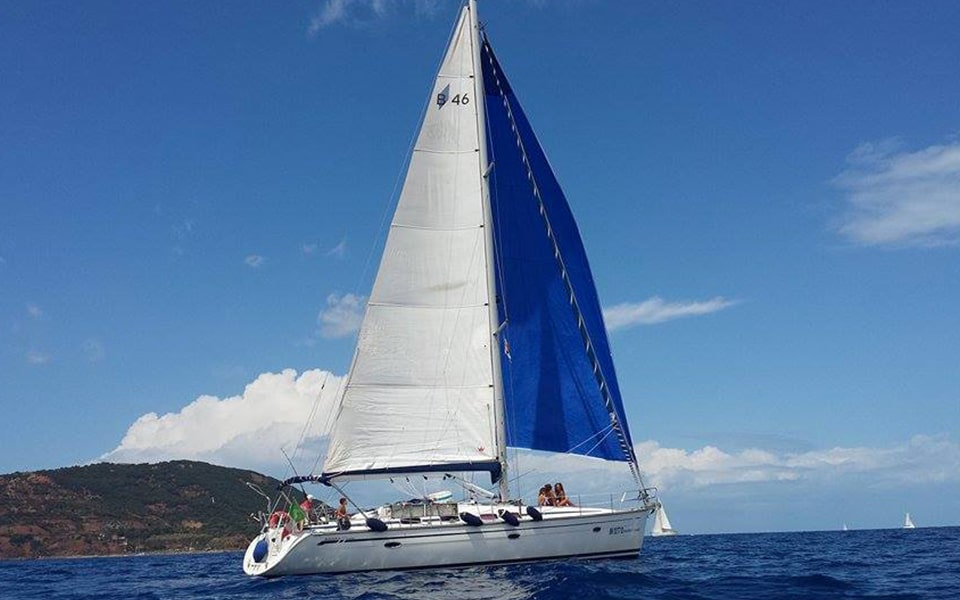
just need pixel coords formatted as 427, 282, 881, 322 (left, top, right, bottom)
243, 0, 657, 577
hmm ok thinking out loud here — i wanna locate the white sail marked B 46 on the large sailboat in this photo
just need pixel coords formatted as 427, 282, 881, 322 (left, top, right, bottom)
324, 7, 499, 476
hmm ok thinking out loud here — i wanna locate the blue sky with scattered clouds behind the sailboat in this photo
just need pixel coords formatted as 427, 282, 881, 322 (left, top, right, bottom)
0, 0, 960, 533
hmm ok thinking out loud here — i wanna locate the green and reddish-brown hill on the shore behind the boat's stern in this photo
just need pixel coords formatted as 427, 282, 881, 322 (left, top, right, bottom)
0, 460, 292, 558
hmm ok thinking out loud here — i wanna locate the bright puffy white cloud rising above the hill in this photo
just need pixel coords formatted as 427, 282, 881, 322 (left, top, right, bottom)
100, 369, 342, 472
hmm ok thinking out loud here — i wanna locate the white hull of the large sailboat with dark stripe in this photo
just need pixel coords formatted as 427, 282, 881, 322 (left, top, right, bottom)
243, 508, 649, 577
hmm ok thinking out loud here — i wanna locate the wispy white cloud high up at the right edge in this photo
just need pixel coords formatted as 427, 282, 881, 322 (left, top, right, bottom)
833, 140, 960, 246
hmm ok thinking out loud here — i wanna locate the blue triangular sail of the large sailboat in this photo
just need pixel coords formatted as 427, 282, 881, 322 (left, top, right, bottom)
482, 39, 636, 464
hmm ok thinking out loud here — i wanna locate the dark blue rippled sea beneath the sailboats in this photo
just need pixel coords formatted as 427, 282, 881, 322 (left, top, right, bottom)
0, 527, 960, 600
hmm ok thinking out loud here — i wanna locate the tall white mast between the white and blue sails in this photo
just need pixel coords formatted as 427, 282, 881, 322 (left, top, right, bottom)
467, 0, 510, 502
